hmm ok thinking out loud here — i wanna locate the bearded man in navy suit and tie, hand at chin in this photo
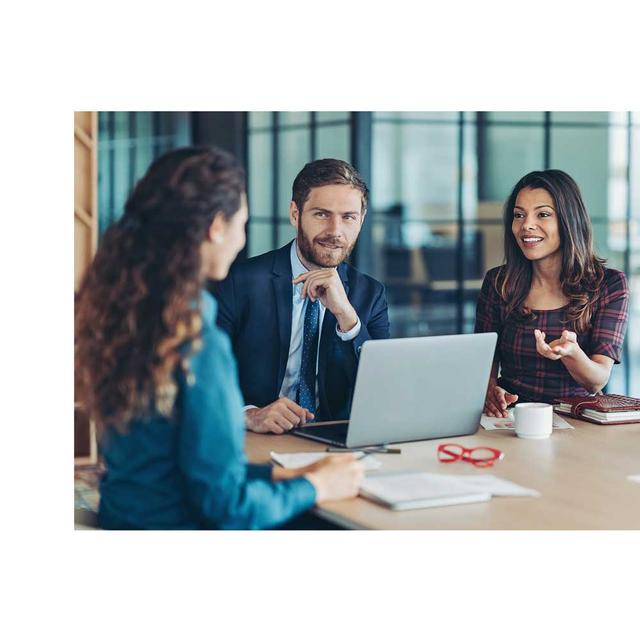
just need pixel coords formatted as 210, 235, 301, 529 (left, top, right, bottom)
215, 159, 389, 433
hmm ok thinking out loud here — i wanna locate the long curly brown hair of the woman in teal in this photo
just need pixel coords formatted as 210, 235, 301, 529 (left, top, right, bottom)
75, 147, 245, 433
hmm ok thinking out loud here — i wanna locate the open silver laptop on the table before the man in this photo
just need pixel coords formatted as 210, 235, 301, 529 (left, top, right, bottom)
291, 333, 497, 448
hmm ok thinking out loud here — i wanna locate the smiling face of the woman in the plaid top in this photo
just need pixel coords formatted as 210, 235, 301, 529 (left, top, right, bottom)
511, 187, 561, 260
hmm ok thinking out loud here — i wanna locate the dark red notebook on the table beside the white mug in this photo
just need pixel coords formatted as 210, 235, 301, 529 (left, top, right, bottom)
555, 393, 640, 424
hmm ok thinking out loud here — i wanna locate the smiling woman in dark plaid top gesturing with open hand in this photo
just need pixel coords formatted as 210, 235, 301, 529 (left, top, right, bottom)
475, 169, 629, 417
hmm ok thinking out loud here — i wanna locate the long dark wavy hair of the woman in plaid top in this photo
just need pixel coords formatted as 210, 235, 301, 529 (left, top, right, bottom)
496, 169, 605, 333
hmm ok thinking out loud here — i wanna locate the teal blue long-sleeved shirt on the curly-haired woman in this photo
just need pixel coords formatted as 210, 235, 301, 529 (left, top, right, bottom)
98, 292, 316, 529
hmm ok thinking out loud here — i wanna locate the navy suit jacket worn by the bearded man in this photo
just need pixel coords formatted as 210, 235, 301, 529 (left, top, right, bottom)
213, 243, 389, 420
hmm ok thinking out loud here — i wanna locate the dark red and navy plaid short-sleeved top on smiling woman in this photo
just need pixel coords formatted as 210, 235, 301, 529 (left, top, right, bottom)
475, 267, 629, 402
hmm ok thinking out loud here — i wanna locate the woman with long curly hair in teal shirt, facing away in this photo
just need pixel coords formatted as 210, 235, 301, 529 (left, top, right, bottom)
75, 148, 362, 529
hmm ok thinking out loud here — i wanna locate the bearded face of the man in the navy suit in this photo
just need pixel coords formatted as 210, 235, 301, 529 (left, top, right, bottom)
289, 184, 365, 268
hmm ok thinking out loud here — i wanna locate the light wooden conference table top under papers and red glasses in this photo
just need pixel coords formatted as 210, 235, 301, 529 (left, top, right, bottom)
246, 418, 640, 529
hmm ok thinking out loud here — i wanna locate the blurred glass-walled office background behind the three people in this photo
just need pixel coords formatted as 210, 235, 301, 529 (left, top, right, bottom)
90, 111, 640, 396
